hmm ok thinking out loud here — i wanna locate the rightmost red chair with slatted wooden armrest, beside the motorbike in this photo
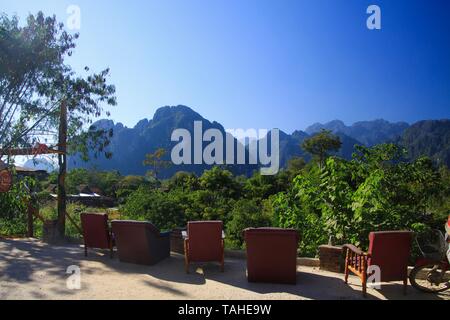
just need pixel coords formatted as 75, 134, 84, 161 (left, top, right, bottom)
344, 231, 413, 296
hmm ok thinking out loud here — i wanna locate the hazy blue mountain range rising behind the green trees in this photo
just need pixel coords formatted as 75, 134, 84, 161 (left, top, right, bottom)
25, 105, 450, 177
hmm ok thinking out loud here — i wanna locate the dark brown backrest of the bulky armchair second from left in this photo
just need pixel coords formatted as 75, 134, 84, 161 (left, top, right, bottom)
111, 220, 160, 264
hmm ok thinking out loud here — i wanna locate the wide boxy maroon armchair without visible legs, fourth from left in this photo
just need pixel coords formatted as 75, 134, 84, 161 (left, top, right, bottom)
244, 228, 299, 284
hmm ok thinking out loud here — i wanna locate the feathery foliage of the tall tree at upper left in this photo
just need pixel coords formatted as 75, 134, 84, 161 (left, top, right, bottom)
0, 12, 116, 158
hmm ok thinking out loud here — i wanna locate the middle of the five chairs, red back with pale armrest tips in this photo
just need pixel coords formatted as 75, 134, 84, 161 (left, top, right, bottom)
184, 221, 224, 273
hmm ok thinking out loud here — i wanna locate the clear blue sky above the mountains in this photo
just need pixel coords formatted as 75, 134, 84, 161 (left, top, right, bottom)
0, 0, 450, 132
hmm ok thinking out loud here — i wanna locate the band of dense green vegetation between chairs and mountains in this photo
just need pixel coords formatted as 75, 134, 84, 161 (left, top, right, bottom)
0, 140, 450, 256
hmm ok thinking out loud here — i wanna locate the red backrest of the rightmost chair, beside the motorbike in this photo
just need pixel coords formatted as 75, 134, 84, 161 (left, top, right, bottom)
368, 231, 413, 281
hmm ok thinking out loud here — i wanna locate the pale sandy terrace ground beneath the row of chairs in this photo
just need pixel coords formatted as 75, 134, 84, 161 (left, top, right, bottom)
0, 239, 450, 300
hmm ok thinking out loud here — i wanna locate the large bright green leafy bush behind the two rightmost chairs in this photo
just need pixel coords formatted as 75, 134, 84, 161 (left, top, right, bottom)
274, 144, 448, 255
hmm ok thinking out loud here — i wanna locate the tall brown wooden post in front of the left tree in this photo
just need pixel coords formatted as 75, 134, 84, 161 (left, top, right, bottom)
57, 101, 67, 240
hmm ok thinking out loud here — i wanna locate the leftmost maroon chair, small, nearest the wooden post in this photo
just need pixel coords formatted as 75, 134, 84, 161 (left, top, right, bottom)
80, 213, 113, 258
